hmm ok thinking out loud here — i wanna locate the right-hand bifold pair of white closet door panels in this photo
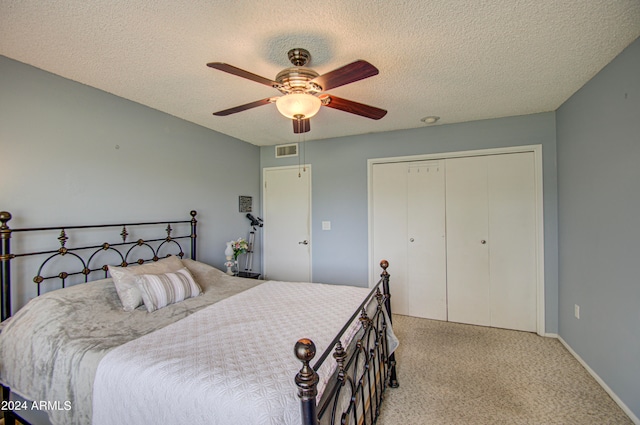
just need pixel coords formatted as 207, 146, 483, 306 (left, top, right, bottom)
446, 152, 537, 332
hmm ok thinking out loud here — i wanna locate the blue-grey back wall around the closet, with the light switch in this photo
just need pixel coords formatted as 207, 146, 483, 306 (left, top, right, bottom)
260, 112, 558, 333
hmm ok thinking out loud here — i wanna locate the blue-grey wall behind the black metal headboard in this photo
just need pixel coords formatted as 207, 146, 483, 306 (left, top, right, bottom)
0, 56, 260, 308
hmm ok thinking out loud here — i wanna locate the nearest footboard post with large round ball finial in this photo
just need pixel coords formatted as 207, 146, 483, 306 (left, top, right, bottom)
294, 338, 319, 425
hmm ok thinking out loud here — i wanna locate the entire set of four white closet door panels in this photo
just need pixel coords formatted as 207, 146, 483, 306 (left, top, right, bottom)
372, 152, 538, 332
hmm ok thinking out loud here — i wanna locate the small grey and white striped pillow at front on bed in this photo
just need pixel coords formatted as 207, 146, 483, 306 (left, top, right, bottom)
136, 267, 202, 312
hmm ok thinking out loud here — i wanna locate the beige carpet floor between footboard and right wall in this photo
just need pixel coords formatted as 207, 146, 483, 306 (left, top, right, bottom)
378, 315, 632, 425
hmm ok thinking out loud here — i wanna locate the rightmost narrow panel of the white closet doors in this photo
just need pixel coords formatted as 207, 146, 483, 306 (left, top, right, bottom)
487, 152, 537, 332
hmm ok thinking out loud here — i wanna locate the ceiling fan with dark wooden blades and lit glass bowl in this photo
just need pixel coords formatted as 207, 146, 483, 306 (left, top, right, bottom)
207, 48, 387, 133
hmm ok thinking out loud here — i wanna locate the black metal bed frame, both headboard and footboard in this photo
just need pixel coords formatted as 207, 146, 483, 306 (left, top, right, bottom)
0, 211, 398, 425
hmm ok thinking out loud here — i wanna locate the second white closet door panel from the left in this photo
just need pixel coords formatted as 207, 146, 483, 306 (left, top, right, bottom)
407, 161, 447, 320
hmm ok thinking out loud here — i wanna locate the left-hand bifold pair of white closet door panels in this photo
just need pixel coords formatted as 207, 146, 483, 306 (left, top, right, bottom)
372, 161, 447, 320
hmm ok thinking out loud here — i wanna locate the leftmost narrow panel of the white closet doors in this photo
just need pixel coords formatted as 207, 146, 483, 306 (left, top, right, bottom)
372, 163, 409, 315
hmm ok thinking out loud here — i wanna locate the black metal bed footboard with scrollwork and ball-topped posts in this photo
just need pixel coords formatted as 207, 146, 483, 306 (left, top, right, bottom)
294, 260, 398, 425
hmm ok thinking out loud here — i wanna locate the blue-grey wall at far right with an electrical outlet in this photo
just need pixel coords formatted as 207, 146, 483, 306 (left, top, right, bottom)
557, 39, 640, 417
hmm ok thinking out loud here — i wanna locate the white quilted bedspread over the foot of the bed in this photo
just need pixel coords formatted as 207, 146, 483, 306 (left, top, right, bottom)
93, 281, 390, 425
